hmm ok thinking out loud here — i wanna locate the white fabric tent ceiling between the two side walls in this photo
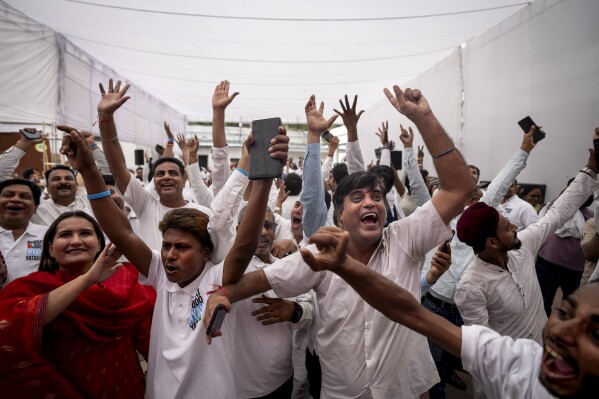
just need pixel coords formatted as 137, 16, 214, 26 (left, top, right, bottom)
7, 0, 529, 123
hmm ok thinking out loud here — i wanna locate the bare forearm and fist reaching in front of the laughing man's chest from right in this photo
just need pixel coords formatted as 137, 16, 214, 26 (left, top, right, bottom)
300, 227, 462, 357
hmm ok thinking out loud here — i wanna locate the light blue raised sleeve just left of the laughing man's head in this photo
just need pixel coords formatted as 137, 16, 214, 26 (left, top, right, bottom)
300, 143, 328, 237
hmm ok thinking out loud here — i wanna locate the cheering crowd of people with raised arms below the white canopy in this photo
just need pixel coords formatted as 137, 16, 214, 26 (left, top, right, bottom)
0, 80, 599, 399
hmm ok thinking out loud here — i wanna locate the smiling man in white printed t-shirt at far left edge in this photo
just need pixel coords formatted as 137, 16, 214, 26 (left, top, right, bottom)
0, 179, 48, 288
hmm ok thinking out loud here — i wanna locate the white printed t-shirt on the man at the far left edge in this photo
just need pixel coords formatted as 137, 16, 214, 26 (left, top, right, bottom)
0, 222, 48, 284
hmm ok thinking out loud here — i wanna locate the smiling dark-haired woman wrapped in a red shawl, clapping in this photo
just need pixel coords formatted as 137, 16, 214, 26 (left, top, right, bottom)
0, 212, 153, 398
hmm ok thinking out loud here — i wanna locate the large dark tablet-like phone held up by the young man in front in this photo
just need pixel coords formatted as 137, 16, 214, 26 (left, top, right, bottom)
249, 118, 283, 180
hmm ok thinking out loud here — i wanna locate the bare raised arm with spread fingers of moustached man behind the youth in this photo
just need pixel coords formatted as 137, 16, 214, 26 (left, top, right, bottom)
96, 79, 131, 193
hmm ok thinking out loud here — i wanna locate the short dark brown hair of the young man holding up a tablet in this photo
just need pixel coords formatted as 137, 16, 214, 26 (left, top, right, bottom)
158, 209, 214, 252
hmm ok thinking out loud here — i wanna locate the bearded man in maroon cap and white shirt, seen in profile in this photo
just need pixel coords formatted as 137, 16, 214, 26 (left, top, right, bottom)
454, 158, 599, 343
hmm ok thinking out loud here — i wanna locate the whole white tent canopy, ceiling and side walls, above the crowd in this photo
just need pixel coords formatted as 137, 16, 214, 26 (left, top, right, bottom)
0, 0, 599, 199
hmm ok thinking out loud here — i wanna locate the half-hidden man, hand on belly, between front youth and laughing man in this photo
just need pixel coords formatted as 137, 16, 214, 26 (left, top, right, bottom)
235, 207, 314, 399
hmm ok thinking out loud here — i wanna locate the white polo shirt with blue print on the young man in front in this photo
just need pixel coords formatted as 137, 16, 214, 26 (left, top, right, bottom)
140, 251, 237, 399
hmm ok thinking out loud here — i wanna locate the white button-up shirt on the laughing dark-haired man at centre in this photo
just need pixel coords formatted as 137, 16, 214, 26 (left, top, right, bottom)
264, 202, 451, 399
